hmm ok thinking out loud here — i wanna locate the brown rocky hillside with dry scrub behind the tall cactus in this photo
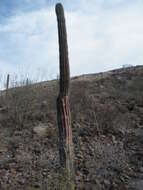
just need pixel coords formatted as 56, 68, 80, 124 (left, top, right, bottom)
0, 66, 143, 190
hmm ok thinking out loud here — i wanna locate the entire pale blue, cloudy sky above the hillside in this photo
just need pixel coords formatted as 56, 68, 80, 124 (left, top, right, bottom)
0, 0, 143, 86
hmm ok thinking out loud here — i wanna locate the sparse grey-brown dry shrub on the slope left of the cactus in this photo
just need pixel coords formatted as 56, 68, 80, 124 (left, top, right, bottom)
5, 85, 37, 127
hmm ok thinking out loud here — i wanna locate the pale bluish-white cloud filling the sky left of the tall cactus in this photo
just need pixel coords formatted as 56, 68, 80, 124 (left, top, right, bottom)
0, 9, 58, 77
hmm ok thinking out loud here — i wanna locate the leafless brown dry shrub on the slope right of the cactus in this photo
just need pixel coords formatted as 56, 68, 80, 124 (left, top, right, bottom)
72, 88, 119, 135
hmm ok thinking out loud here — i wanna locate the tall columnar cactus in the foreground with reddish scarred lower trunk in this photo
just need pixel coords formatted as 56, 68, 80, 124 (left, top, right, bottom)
56, 3, 74, 187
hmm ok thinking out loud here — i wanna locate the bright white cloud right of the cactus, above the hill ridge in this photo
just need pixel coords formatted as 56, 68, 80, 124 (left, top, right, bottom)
68, 0, 143, 74
